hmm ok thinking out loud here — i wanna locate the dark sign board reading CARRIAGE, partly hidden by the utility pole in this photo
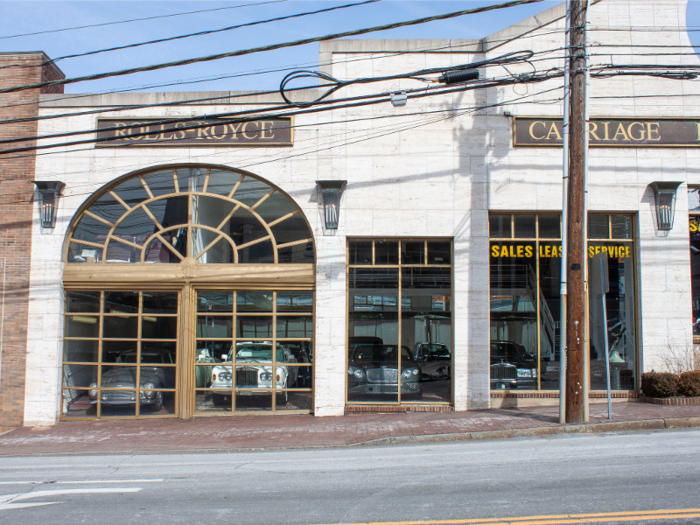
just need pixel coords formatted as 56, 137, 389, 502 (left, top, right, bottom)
513, 117, 700, 148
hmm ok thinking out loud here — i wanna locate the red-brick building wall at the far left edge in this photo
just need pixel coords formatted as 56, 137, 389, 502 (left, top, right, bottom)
0, 52, 64, 427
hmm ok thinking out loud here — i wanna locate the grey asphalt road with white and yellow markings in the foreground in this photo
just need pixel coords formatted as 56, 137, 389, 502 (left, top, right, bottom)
0, 431, 700, 525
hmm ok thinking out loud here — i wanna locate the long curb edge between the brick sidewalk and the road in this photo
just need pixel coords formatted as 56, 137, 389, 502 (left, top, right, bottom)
0, 417, 700, 457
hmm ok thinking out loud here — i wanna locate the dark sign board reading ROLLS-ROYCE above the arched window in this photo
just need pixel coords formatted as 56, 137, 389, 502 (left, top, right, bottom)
95, 117, 294, 148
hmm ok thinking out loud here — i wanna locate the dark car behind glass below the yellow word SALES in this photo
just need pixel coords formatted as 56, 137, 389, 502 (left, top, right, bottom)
491, 341, 537, 390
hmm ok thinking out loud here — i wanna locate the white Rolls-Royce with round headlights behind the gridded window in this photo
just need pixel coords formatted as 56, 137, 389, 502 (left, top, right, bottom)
211, 341, 298, 405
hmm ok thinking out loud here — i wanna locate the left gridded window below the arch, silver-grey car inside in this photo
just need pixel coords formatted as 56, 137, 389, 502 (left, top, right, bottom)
62, 291, 179, 419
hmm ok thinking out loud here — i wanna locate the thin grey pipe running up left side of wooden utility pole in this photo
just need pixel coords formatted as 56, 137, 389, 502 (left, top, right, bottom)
559, 0, 571, 424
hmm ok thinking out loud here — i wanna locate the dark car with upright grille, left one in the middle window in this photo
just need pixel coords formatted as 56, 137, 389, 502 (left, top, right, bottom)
348, 343, 420, 394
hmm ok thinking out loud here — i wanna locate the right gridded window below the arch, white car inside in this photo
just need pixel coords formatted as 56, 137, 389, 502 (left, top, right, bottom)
194, 290, 313, 414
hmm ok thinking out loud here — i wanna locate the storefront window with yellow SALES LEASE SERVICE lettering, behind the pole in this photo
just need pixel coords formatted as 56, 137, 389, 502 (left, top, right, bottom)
489, 214, 636, 390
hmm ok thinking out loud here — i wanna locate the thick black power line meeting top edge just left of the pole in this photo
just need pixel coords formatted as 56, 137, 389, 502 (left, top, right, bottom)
0, 0, 543, 93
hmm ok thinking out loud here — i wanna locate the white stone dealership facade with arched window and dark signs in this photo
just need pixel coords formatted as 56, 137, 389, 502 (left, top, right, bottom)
0, 0, 700, 426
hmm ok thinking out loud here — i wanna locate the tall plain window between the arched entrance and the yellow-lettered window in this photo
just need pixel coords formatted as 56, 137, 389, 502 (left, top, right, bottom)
347, 239, 452, 404
